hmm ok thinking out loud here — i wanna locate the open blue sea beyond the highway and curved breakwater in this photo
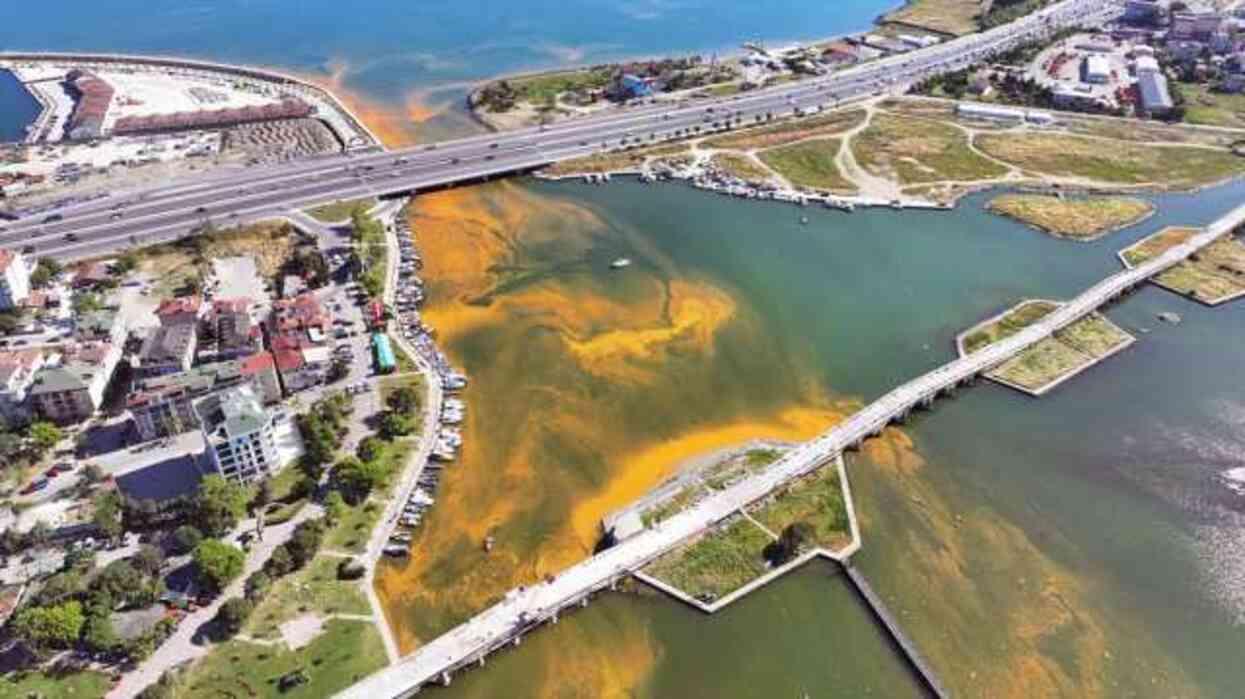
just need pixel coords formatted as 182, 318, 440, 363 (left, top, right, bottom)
0, 0, 895, 100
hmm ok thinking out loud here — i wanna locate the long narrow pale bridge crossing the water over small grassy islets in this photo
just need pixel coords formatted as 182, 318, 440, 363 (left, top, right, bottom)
339, 206, 1245, 699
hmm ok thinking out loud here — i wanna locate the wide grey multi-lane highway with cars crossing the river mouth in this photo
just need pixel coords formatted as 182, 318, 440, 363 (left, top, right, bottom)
0, 0, 1121, 260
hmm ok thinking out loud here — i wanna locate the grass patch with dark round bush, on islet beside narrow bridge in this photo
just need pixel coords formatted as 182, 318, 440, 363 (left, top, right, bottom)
751, 466, 852, 551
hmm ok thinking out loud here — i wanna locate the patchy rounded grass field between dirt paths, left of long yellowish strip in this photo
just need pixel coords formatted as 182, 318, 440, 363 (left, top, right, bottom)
852, 113, 1007, 184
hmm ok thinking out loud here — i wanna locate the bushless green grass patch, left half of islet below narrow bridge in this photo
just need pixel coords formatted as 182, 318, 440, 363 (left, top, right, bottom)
644, 517, 773, 599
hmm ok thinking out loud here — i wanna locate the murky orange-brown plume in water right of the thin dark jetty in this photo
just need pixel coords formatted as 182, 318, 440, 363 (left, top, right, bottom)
855, 430, 1198, 699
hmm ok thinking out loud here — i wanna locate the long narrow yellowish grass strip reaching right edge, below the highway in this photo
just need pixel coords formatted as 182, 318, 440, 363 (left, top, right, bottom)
977, 133, 1245, 187
